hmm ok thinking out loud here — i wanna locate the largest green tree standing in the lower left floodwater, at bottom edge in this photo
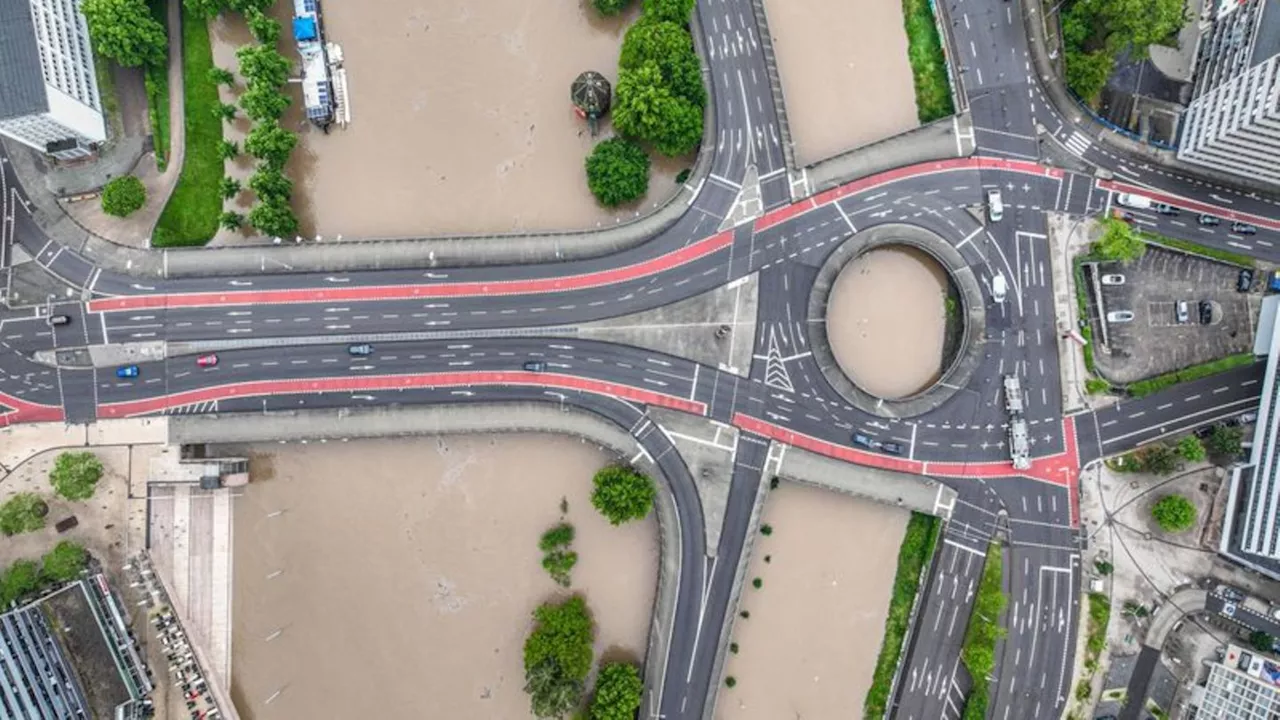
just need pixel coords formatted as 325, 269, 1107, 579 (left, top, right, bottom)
524, 596, 595, 717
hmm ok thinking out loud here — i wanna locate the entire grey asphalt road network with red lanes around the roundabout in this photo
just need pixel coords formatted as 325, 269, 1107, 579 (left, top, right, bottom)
0, 0, 1280, 720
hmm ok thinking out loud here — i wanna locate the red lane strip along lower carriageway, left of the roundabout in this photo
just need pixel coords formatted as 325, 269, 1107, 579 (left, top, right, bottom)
97, 370, 707, 418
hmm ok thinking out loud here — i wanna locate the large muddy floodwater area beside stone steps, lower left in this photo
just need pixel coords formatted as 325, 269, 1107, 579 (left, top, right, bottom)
232, 434, 658, 720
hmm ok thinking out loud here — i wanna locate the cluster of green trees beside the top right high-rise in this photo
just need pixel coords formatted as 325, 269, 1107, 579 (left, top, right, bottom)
1062, 0, 1187, 104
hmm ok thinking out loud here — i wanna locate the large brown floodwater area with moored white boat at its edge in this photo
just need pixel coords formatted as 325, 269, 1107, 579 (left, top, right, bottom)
247, 0, 692, 240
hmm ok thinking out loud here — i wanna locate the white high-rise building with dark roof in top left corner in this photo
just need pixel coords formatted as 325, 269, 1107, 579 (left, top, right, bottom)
0, 0, 106, 159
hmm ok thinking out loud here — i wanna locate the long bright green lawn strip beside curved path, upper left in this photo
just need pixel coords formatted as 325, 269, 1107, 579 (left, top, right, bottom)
151, 6, 223, 247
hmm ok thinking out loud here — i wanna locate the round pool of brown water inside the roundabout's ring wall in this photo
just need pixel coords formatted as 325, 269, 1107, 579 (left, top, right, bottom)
827, 247, 947, 398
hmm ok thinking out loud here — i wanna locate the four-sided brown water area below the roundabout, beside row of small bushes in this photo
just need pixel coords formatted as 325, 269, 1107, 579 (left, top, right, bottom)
716, 483, 910, 720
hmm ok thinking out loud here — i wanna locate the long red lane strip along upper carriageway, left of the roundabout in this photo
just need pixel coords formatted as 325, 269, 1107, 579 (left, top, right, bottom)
88, 231, 733, 313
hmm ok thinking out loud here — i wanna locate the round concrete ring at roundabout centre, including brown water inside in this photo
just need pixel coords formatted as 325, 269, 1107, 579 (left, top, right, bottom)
808, 223, 987, 418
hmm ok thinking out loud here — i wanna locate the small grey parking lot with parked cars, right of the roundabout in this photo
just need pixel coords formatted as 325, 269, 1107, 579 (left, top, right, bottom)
1084, 246, 1262, 383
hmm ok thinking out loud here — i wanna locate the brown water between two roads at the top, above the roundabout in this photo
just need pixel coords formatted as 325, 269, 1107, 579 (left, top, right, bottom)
764, 0, 919, 167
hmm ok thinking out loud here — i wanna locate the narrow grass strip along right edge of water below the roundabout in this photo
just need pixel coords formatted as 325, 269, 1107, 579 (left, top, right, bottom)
863, 512, 938, 719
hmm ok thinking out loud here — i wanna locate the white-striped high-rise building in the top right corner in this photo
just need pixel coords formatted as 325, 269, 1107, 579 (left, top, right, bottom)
1178, 0, 1280, 184
